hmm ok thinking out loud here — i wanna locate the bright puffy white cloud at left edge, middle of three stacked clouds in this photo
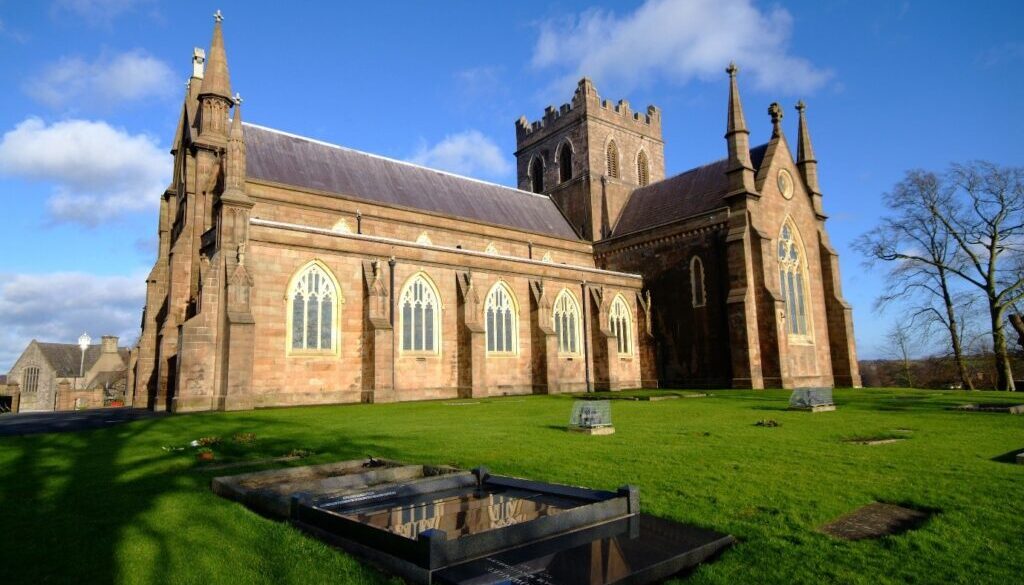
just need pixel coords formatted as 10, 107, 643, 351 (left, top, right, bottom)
0, 118, 171, 225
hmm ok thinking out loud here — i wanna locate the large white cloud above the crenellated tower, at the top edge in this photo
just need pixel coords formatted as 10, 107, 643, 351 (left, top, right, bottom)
532, 0, 831, 93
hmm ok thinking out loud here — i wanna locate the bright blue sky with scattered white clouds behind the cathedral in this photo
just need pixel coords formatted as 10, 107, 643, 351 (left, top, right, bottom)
0, 0, 1024, 372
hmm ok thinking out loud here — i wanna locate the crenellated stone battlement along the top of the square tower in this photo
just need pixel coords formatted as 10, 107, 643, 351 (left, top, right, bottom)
515, 77, 662, 143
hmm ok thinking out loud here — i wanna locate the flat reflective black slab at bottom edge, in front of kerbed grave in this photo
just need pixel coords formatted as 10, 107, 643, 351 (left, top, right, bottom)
432, 514, 734, 585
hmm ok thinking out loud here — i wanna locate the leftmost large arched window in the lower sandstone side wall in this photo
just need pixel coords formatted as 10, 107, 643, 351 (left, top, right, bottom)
288, 261, 341, 353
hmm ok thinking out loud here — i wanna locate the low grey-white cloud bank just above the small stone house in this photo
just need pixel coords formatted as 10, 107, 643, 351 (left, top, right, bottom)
0, 273, 145, 373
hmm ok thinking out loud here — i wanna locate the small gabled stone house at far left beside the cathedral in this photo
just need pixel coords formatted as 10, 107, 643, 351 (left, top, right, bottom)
7, 335, 128, 412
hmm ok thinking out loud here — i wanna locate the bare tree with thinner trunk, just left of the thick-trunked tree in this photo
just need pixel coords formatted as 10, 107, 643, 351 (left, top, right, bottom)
854, 170, 974, 389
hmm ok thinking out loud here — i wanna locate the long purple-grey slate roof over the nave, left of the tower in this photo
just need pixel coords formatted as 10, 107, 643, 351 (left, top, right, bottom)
243, 123, 580, 240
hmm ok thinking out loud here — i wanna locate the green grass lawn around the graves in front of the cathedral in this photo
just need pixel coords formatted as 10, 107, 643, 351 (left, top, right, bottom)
0, 389, 1024, 585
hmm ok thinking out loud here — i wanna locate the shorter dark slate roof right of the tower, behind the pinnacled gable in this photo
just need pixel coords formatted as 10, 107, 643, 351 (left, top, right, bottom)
612, 144, 768, 237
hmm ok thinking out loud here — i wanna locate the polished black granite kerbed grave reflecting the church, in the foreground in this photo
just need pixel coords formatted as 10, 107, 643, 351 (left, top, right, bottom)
211, 462, 734, 585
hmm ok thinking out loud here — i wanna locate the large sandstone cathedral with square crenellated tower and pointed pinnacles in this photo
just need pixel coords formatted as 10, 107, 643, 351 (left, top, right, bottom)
128, 13, 860, 412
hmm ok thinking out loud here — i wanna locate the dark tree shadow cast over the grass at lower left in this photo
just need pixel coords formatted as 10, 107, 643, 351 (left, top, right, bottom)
0, 415, 395, 584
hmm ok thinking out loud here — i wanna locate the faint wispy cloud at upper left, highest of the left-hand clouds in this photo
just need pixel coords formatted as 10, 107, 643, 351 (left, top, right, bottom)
23, 49, 176, 109
